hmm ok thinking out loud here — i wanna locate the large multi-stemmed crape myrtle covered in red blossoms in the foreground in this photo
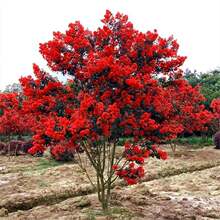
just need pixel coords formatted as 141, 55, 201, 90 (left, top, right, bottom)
23, 10, 211, 210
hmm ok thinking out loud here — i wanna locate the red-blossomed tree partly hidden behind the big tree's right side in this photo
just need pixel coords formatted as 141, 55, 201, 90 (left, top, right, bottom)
162, 80, 215, 153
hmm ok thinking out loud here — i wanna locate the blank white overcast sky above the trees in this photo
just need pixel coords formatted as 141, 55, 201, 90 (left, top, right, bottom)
0, 0, 220, 90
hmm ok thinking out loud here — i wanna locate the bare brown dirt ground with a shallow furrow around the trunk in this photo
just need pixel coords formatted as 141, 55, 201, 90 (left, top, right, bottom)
0, 146, 220, 220
